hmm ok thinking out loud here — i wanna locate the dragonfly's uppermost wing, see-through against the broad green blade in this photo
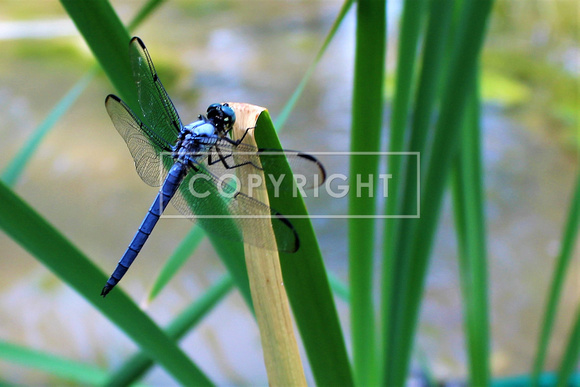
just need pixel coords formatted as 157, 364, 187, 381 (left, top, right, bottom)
129, 37, 182, 144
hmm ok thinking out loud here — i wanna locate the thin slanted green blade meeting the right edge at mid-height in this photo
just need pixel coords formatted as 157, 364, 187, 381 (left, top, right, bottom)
532, 174, 580, 386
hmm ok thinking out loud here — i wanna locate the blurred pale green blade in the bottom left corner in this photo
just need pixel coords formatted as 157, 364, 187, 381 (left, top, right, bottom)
0, 341, 107, 385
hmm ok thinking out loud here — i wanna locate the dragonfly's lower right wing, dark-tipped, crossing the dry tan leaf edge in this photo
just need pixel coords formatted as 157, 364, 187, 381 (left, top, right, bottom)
171, 165, 299, 252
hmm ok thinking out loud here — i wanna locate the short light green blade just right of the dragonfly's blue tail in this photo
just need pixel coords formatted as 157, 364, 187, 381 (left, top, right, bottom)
147, 225, 205, 303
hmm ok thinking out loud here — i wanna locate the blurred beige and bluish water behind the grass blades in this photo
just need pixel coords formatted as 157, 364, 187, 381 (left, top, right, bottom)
0, 0, 580, 385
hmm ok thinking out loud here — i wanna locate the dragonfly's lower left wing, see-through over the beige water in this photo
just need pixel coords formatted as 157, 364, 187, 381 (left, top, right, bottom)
105, 94, 174, 187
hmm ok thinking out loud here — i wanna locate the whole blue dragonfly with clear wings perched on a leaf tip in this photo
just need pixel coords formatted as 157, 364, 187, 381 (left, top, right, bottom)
101, 37, 325, 297
